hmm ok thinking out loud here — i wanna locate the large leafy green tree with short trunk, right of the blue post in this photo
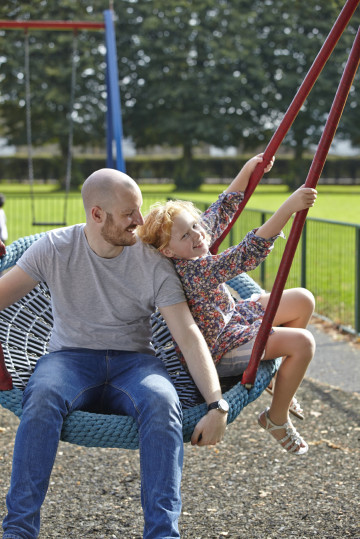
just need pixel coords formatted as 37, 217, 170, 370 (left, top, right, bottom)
116, 0, 267, 187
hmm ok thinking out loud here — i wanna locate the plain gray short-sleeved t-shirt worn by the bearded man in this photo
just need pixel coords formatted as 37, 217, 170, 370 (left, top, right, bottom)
17, 224, 185, 354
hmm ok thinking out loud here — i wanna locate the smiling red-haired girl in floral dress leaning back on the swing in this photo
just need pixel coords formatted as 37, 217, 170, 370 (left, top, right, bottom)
139, 154, 316, 455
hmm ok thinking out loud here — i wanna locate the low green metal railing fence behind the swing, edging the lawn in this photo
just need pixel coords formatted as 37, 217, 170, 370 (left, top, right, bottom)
4, 193, 360, 334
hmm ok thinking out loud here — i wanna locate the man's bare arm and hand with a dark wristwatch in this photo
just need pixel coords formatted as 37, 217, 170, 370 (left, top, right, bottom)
160, 301, 227, 445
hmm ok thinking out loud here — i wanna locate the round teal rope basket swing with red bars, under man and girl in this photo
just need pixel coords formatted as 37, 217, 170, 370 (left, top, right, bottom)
0, 0, 360, 449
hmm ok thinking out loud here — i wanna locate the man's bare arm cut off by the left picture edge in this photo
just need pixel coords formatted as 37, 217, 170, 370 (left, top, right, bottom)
0, 266, 38, 311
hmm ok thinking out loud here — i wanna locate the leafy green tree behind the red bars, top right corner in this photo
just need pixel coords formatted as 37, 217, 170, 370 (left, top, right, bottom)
255, 0, 360, 187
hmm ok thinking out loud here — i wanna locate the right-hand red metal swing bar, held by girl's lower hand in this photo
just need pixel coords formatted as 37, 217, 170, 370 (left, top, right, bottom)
241, 28, 360, 387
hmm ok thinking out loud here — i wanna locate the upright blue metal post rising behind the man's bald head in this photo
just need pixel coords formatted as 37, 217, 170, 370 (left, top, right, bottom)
104, 9, 126, 172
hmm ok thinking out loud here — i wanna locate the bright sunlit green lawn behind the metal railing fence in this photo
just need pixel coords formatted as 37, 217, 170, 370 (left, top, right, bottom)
0, 183, 360, 327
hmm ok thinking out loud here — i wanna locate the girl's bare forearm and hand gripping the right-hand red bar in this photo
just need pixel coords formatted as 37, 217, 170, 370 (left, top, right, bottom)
255, 186, 317, 239
